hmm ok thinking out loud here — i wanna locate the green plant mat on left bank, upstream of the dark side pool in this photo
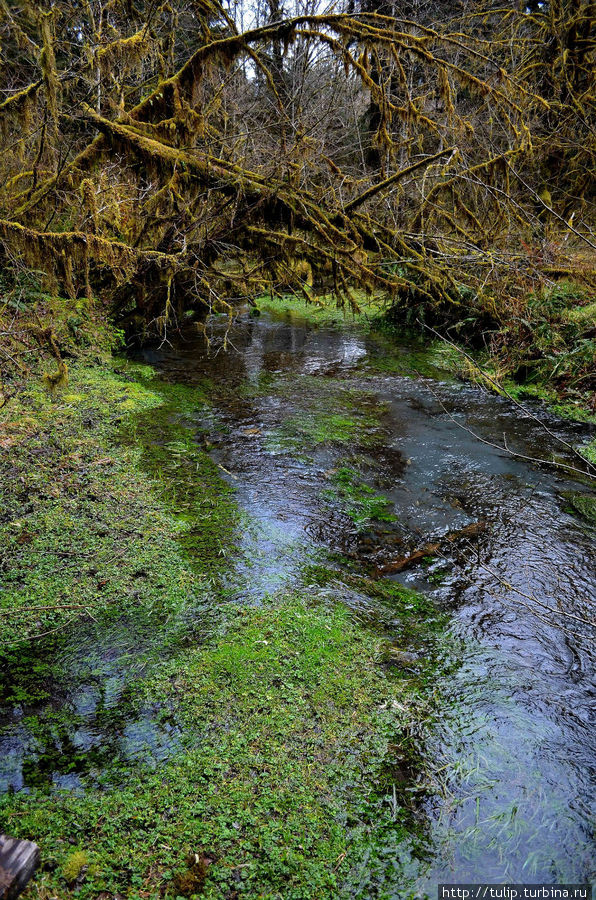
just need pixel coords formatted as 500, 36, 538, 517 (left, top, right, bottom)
0, 362, 237, 643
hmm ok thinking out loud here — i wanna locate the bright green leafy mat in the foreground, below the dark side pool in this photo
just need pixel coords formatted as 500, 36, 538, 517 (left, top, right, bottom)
2, 597, 436, 900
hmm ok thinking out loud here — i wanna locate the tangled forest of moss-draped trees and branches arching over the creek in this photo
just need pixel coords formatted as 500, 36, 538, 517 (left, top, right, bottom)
0, 0, 596, 396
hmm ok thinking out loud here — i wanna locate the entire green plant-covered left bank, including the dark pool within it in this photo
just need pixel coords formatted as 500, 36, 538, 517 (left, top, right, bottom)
0, 312, 440, 900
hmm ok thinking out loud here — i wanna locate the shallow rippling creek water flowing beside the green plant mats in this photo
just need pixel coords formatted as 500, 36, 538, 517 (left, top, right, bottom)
2, 306, 596, 893
